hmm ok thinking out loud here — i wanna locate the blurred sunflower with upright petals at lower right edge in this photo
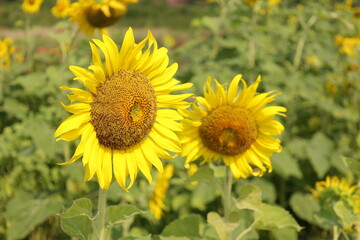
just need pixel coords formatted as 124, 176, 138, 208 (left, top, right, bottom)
310, 176, 360, 214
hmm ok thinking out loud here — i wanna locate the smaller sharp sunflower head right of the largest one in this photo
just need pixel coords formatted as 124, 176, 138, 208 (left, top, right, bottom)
180, 75, 286, 178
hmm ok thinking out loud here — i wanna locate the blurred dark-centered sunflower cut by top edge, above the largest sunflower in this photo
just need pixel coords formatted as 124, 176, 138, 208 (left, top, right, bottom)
70, 0, 137, 36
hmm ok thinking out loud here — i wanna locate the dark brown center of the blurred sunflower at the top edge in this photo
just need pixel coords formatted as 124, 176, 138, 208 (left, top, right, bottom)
85, 6, 125, 28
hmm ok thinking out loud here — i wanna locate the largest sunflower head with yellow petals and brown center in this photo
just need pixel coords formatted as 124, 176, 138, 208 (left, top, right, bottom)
55, 28, 192, 190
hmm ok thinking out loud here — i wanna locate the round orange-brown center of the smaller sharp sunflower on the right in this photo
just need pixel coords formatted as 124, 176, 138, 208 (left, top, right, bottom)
199, 105, 258, 155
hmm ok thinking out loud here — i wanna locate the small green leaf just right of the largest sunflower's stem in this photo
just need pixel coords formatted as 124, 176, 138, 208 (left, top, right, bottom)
106, 205, 142, 226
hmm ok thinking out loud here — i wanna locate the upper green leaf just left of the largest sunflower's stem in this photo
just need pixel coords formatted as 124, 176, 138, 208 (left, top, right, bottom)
61, 198, 93, 219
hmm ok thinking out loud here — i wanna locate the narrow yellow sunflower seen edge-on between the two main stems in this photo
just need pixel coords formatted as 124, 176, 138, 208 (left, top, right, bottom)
149, 164, 174, 220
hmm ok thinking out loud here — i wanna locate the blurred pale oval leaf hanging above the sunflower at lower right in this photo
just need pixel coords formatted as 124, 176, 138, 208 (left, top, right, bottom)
306, 132, 334, 178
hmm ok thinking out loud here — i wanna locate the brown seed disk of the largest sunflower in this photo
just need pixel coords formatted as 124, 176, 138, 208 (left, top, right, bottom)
90, 70, 156, 150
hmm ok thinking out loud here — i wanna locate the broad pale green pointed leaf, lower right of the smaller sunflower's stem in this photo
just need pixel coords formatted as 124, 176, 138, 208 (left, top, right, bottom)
255, 203, 301, 231
